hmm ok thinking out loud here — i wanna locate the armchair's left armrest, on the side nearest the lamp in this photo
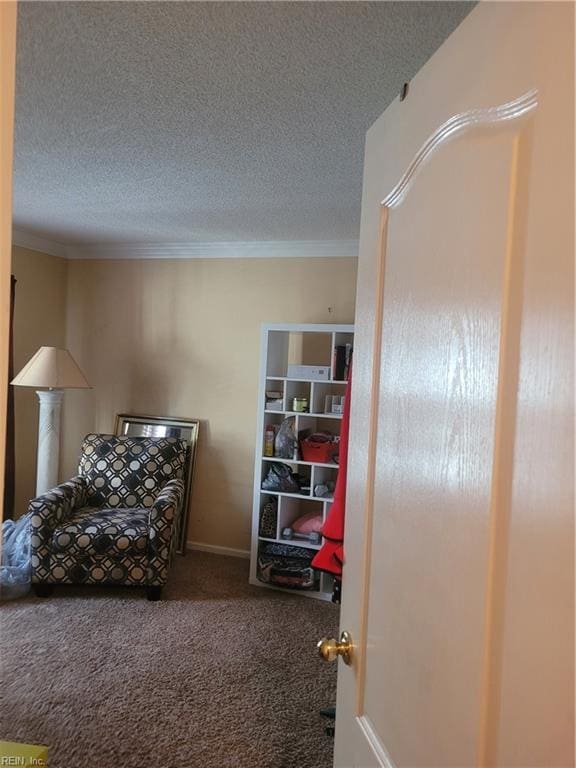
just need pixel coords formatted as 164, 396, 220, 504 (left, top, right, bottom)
28, 475, 87, 582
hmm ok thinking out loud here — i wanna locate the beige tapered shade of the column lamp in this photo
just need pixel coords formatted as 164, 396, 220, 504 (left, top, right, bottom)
11, 347, 90, 389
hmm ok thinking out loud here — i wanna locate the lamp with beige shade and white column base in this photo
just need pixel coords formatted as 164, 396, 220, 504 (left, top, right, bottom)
11, 347, 90, 496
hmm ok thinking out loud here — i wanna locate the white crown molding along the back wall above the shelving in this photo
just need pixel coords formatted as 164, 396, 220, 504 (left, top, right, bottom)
66, 240, 358, 259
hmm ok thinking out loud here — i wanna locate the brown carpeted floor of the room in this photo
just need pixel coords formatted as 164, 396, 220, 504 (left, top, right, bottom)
0, 552, 338, 768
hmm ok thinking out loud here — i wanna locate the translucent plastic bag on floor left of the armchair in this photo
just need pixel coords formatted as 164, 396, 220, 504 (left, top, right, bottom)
0, 515, 31, 600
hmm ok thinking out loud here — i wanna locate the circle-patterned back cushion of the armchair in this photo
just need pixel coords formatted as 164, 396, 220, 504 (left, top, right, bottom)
79, 435, 187, 507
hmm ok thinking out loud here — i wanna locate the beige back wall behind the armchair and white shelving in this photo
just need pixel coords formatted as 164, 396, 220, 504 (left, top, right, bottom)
61, 258, 357, 549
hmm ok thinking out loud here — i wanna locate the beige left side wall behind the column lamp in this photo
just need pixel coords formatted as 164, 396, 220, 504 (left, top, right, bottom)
12, 246, 68, 516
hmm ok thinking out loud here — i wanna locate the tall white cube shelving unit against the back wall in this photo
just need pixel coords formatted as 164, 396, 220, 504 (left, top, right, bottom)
250, 324, 354, 600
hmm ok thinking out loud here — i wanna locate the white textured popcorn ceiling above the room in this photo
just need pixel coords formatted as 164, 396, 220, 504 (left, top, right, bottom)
14, 1, 473, 244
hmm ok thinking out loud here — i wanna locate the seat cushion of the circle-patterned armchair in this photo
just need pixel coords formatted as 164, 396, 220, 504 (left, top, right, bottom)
52, 507, 150, 558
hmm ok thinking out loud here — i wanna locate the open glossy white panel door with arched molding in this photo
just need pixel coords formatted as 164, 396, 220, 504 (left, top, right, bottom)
335, 3, 574, 768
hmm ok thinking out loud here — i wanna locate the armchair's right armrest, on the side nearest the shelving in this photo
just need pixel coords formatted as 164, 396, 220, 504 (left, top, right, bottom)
147, 479, 184, 586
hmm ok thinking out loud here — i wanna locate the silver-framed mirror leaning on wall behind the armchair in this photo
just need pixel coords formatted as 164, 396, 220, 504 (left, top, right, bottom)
115, 413, 200, 555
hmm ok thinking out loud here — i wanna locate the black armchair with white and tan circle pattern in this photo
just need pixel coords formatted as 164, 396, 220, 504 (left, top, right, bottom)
29, 435, 187, 600
